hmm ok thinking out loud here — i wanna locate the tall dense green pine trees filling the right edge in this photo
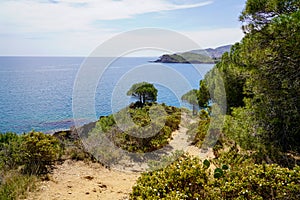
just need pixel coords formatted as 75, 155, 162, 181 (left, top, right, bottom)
207, 0, 300, 157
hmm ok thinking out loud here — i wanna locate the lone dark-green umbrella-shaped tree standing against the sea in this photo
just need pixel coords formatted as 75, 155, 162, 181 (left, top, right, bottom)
127, 82, 157, 104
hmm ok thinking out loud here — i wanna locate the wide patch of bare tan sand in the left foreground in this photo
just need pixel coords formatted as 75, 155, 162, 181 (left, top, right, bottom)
27, 160, 139, 200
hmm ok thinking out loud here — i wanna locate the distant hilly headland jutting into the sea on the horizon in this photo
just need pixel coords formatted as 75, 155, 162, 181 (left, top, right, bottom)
154, 45, 232, 63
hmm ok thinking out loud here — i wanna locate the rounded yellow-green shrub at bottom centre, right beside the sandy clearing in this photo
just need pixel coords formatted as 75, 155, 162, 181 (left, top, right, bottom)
130, 156, 208, 199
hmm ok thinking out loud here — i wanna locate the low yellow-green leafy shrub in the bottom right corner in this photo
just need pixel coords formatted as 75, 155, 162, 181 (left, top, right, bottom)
212, 163, 300, 200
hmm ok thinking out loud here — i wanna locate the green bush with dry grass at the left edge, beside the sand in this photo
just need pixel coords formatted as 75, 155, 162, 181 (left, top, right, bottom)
0, 131, 61, 200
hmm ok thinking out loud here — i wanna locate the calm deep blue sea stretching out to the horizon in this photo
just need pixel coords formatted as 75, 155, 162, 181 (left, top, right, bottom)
0, 57, 213, 133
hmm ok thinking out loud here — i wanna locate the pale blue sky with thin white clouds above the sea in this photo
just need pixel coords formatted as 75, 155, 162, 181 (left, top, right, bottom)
0, 0, 245, 56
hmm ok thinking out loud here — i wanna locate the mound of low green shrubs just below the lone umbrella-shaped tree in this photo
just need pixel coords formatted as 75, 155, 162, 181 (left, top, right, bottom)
87, 103, 181, 156
